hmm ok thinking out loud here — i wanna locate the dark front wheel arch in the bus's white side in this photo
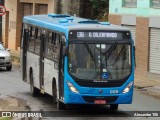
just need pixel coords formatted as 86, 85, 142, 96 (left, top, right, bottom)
52, 79, 57, 104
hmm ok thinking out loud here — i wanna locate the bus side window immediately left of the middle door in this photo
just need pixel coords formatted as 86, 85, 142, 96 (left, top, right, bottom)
35, 28, 41, 54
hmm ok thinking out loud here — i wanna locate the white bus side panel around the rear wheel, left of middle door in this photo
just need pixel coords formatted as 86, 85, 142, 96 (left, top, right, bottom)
27, 52, 40, 88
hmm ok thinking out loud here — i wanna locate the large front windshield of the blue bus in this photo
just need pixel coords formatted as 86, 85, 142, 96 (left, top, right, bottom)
68, 42, 131, 81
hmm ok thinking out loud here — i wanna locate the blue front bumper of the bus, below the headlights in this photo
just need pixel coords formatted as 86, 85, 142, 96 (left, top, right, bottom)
64, 91, 133, 104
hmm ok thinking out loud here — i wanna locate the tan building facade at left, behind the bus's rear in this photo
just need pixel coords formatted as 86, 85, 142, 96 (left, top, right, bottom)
2, 0, 54, 50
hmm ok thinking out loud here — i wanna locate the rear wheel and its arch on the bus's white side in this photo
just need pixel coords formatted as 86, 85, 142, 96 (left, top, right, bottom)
30, 72, 40, 97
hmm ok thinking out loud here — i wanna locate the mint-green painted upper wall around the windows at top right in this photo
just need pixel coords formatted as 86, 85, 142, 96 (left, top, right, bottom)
109, 0, 160, 17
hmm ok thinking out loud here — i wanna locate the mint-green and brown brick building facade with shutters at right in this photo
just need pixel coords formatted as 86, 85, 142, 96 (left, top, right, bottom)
109, 0, 160, 80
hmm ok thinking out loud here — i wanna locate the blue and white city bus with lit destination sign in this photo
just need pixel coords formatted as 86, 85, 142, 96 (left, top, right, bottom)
21, 14, 134, 110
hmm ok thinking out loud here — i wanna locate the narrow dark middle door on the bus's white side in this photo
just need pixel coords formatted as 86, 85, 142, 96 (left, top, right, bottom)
39, 33, 46, 93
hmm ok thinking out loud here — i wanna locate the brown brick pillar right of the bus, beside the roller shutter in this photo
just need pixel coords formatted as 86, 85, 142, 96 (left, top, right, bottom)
135, 17, 149, 78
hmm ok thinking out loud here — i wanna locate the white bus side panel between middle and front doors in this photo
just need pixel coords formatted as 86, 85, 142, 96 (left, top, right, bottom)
44, 59, 58, 95
